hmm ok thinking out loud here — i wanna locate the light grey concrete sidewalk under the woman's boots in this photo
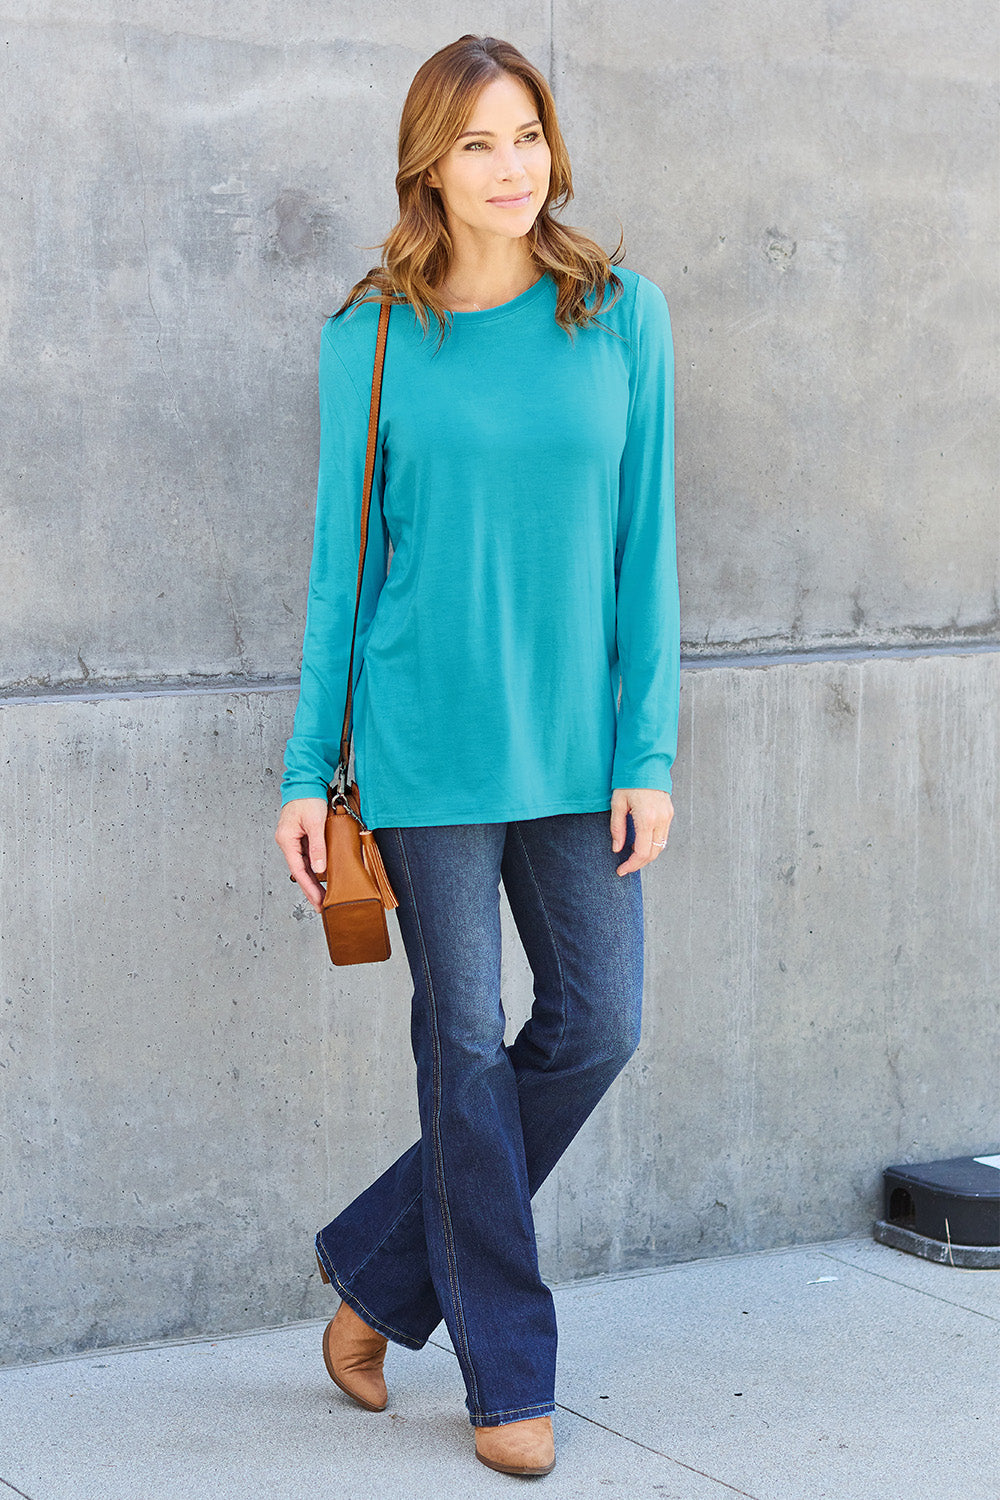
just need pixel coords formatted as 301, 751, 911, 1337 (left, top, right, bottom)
0, 1239, 1000, 1500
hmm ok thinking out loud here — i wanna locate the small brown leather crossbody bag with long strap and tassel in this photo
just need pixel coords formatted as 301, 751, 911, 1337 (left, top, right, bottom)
316, 303, 399, 963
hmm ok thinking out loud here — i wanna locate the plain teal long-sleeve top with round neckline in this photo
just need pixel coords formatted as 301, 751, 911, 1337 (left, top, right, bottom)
282, 267, 679, 828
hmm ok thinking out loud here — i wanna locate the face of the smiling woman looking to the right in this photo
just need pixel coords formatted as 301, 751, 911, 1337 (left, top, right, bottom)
427, 74, 552, 249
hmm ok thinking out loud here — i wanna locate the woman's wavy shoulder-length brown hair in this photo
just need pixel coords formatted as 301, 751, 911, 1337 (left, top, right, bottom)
334, 33, 622, 338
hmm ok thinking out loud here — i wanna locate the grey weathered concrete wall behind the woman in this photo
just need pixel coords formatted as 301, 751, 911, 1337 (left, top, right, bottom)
0, 0, 1000, 1361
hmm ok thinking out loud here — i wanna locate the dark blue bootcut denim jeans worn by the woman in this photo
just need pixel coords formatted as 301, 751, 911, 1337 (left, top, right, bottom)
316, 812, 643, 1427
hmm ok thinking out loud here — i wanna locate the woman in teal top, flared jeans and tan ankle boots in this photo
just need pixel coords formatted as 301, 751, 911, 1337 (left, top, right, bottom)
276, 36, 679, 1475
